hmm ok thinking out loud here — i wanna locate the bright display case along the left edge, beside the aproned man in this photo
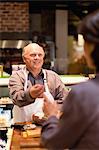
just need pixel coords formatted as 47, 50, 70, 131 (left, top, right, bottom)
0, 72, 13, 150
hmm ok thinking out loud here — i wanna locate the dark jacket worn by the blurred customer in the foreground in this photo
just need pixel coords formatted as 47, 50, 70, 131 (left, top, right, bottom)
41, 75, 99, 150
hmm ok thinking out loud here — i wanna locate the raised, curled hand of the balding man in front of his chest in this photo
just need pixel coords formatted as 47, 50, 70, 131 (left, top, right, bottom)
30, 84, 44, 98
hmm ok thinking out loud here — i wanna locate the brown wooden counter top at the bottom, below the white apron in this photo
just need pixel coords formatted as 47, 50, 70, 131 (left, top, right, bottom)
10, 127, 46, 150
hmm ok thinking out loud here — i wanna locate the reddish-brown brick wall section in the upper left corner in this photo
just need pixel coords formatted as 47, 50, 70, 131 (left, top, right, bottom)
0, 2, 29, 39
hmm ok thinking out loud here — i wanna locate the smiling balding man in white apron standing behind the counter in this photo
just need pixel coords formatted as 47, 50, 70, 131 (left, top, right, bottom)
9, 43, 68, 122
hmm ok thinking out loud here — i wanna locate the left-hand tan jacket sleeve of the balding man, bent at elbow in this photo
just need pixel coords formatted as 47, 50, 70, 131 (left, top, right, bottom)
8, 72, 35, 107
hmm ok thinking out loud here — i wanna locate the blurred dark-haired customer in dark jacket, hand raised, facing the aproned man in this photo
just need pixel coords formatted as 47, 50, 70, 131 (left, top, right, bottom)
41, 10, 99, 150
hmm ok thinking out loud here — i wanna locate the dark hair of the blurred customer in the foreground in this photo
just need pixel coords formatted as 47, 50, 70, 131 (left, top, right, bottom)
78, 9, 99, 71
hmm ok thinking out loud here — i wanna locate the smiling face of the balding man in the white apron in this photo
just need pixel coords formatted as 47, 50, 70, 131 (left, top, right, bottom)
24, 46, 45, 70
